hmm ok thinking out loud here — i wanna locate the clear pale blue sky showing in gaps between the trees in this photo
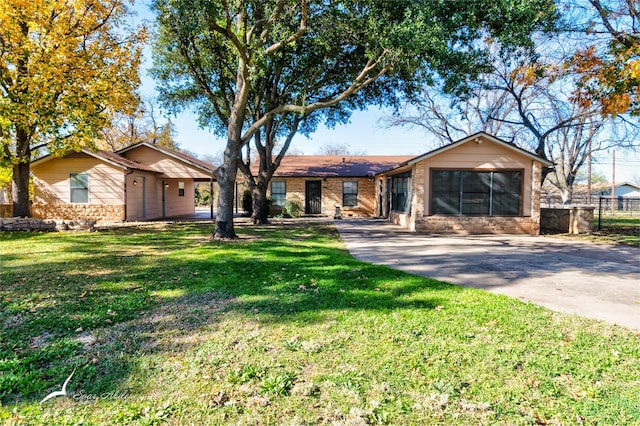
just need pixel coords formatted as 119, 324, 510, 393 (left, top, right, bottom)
135, 0, 640, 183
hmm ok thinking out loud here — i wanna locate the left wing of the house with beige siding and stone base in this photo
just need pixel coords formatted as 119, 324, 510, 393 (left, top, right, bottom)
31, 142, 215, 221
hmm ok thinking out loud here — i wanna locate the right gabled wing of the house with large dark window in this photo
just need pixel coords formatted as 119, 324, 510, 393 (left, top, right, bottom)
377, 132, 552, 235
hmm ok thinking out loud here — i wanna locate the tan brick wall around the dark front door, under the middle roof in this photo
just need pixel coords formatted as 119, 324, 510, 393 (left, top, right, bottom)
267, 177, 375, 217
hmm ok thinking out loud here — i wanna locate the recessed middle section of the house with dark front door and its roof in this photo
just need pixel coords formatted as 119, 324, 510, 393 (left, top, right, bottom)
268, 155, 412, 217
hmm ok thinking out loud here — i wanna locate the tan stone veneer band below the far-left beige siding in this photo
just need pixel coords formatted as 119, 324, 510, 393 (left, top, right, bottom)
31, 204, 125, 222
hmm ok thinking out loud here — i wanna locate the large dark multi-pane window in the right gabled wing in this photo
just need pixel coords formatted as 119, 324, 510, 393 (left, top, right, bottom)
431, 170, 522, 216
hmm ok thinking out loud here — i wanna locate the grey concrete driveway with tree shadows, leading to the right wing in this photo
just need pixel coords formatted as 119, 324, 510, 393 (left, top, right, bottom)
335, 219, 640, 330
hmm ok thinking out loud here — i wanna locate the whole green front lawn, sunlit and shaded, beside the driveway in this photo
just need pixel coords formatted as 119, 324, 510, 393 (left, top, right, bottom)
0, 224, 640, 425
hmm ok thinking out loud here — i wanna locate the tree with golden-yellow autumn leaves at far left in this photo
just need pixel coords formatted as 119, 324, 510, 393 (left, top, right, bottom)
0, 0, 145, 216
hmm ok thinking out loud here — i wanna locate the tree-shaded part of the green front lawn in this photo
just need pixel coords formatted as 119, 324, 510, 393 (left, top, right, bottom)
0, 223, 456, 404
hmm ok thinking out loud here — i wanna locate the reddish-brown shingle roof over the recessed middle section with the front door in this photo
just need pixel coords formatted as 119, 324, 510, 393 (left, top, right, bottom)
266, 155, 414, 177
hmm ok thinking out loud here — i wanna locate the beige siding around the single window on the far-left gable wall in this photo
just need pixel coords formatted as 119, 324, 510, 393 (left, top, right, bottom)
32, 155, 125, 205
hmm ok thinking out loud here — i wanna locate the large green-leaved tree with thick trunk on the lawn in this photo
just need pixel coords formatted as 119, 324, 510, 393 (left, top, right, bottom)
154, 0, 555, 238
